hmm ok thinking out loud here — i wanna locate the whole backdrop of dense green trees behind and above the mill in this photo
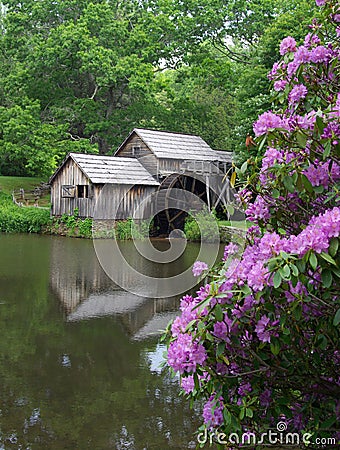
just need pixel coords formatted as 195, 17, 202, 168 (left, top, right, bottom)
0, 0, 314, 176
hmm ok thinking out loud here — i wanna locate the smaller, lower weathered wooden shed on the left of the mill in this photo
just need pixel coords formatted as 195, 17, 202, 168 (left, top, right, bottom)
50, 153, 159, 219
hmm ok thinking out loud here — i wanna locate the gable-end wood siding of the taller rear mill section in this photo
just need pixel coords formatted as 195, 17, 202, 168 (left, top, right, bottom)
115, 135, 159, 176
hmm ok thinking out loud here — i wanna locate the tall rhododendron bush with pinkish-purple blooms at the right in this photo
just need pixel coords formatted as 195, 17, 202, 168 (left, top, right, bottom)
167, 0, 340, 442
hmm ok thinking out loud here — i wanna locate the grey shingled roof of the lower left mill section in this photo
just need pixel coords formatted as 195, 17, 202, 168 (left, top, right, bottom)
50, 153, 159, 186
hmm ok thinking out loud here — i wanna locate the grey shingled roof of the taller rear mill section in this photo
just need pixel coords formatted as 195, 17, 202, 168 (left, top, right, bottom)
116, 128, 232, 162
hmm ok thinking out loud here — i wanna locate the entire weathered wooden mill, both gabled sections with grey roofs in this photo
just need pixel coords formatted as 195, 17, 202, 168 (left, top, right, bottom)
50, 128, 231, 231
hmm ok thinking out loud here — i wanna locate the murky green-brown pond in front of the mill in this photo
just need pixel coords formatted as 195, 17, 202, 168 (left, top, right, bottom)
0, 235, 223, 450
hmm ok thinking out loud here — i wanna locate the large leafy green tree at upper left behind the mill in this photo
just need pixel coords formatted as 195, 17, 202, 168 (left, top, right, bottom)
2, 0, 232, 160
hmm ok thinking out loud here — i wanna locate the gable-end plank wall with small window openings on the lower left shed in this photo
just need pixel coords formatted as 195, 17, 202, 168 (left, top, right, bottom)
51, 158, 94, 217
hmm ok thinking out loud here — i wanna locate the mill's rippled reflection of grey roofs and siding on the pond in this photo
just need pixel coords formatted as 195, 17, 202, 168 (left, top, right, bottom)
50, 238, 179, 339
